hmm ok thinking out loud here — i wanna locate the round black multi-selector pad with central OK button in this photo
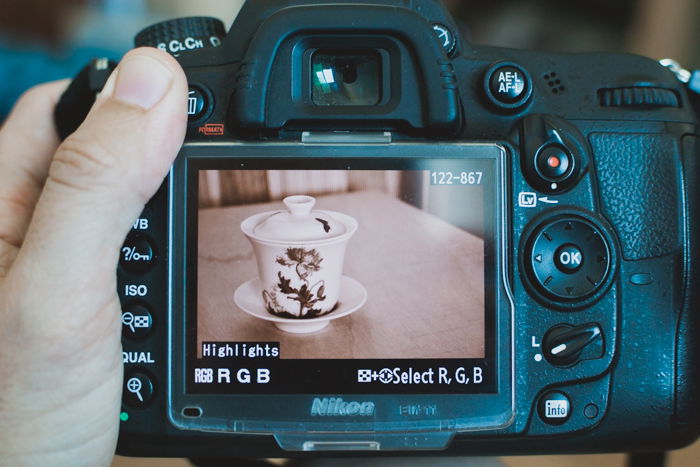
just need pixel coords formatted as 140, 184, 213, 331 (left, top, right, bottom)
525, 216, 611, 302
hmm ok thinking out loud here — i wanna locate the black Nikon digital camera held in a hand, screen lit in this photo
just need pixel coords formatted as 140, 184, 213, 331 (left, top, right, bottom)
57, 0, 700, 457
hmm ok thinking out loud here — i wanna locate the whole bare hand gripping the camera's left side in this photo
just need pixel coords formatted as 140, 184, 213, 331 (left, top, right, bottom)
0, 49, 187, 466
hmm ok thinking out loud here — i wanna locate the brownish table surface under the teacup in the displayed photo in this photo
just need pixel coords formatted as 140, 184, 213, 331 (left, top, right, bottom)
197, 192, 485, 358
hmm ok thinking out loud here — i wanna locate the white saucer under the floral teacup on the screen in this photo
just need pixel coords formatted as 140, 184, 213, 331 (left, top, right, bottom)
233, 276, 367, 334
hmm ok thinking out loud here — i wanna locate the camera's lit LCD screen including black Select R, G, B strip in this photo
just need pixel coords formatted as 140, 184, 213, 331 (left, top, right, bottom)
187, 159, 496, 394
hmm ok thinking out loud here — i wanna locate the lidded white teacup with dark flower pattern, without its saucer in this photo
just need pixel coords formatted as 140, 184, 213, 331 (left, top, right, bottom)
241, 196, 358, 319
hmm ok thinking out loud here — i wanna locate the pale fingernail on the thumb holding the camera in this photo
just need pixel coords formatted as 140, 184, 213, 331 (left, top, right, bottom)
114, 55, 173, 110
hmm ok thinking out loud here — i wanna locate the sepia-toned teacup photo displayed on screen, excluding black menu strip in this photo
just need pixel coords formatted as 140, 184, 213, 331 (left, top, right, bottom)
197, 170, 485, 359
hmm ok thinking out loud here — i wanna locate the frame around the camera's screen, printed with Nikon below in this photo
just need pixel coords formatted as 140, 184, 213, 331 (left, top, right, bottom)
168, 143, 513, 434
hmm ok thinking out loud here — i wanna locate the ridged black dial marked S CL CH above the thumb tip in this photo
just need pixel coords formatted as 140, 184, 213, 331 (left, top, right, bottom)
134, 16, 226, 57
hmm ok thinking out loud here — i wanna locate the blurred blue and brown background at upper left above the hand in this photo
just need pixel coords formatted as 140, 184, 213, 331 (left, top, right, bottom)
0, 0, 242, 122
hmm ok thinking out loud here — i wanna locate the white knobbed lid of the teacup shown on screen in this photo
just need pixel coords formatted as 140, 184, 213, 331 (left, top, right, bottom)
253, 195, 347, 242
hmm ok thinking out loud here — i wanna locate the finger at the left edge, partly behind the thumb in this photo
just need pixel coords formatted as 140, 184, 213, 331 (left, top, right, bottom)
0, 81, 68, 277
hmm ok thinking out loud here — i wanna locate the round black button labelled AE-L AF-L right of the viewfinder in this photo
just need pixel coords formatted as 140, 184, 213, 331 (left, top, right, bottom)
484, 63, 532, 110
